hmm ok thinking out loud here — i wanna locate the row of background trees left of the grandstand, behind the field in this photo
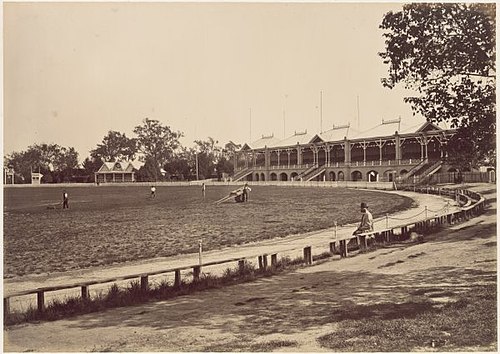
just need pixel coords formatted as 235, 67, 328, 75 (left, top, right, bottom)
4, 118, 240, 183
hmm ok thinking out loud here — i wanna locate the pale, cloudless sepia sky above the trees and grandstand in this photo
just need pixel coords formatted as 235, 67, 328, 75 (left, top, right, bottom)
3, 2, 423, 161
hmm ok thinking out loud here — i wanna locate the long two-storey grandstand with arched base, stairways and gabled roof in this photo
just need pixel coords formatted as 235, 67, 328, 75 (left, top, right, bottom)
233, 119, 456, 182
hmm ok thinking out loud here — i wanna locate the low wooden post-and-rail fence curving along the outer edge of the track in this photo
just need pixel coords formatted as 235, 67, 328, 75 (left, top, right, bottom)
3, 187, 485, 316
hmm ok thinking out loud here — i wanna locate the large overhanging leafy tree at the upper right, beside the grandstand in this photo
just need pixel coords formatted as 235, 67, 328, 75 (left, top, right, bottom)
379, 3, 496, 167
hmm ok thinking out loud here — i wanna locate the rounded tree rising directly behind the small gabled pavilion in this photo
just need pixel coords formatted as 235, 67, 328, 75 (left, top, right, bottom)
90, 130, 137, 162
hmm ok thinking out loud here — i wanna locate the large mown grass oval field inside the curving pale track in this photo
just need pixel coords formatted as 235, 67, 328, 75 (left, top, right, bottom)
4, 186, 412, 278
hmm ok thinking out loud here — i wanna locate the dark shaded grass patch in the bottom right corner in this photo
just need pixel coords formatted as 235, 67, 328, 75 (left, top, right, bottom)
318, 285, 497, 352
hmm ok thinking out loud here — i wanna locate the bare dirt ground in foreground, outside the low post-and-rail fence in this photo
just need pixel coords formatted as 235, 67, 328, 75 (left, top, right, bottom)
4, 186, 497, 352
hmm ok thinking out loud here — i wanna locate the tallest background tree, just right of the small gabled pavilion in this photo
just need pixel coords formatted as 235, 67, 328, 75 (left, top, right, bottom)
134, 118, 183, 166
